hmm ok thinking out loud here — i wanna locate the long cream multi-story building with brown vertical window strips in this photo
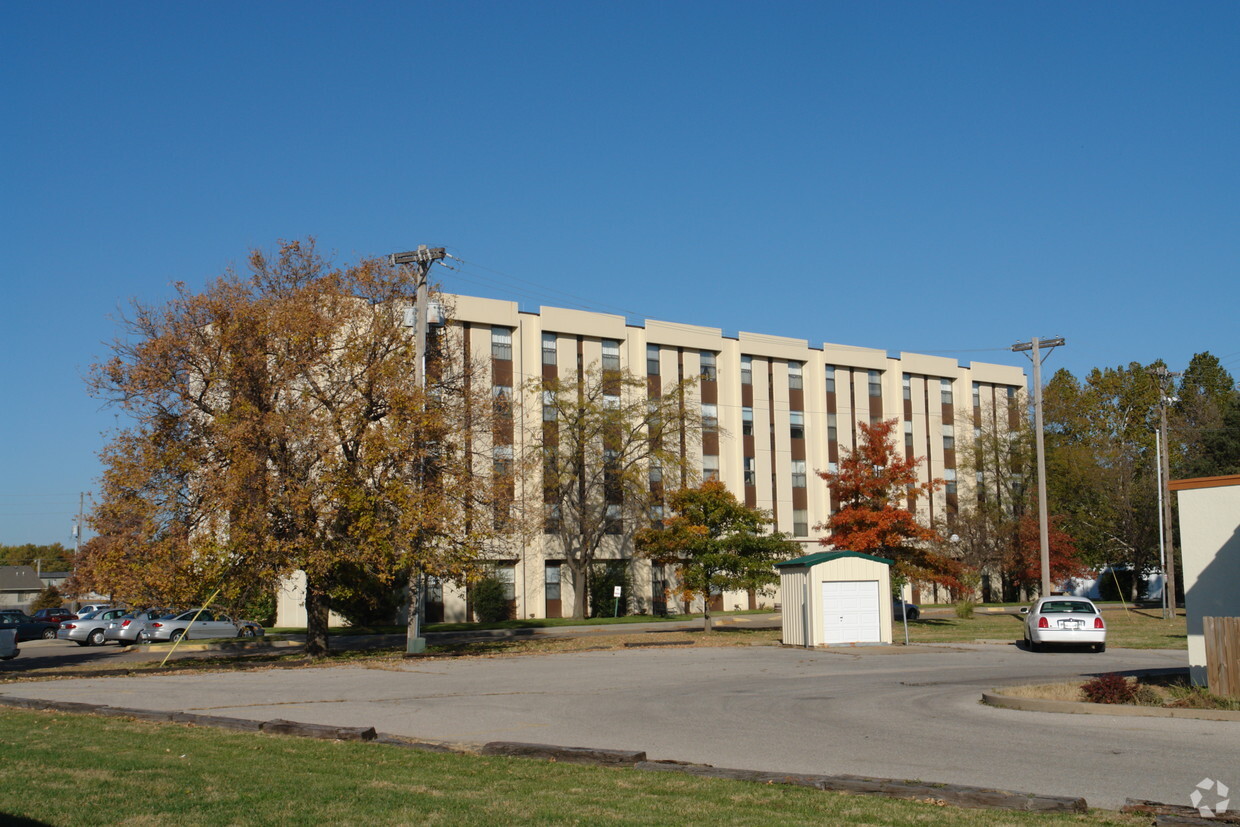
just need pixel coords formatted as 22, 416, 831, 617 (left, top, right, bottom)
280, 296, 1025, 624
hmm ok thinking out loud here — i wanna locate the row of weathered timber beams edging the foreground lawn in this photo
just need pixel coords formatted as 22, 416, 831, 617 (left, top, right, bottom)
0, 694, 1087, 812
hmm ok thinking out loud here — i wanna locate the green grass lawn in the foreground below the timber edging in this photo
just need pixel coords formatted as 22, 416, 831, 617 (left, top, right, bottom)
0, 708, 1149, 827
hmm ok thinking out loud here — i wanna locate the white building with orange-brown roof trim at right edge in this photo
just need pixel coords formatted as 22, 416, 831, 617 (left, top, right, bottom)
1171, 474, 1240, 686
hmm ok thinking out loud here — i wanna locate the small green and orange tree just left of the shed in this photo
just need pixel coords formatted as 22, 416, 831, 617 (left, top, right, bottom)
636, 480, 800, 631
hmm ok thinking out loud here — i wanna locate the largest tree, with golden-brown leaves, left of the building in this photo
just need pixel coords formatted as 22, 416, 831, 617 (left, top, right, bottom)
79, 242, 495, 655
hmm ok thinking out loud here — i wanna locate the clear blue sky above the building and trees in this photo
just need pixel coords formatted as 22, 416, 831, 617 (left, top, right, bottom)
0, 0, 1240, 544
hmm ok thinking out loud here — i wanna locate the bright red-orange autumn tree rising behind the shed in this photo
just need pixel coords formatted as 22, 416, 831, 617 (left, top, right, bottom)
818, 419, 960, 589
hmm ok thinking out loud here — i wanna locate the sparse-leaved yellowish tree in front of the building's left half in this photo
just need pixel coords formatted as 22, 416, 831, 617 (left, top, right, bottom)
525, 365, 702, 617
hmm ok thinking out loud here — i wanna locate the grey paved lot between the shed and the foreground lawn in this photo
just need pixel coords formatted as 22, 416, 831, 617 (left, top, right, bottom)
0, 646, 1240, 808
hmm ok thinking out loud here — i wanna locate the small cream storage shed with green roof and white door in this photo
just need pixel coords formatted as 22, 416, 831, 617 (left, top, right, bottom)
775, 552, 893, 646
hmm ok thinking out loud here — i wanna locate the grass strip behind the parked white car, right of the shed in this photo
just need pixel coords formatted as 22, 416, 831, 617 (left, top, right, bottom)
893, 609, 1188, 648
